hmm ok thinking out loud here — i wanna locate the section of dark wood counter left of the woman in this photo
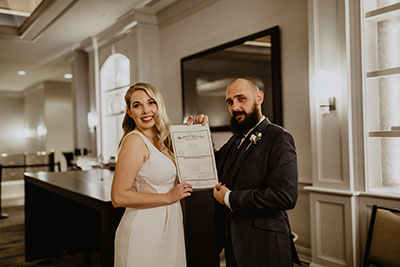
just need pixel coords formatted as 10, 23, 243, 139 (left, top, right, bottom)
25, 169, 124, 266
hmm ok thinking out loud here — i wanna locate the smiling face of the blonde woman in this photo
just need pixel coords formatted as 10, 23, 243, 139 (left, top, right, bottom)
126, 90, 158, 131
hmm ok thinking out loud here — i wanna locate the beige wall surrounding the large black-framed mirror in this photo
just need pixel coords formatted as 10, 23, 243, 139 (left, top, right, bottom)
160, 0, 312, 253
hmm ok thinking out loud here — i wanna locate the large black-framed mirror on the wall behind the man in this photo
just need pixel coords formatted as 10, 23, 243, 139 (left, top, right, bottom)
181, 26, 282, 131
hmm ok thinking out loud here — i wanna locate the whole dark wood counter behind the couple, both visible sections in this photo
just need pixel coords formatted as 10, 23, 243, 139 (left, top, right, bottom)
25, 169, 219, 267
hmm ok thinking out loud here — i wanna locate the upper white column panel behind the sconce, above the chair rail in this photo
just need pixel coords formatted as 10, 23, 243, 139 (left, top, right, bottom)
308, 0, 353, 190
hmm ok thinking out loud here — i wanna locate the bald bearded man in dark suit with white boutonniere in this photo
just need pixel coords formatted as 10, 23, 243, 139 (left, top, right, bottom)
188, 78, 300, 267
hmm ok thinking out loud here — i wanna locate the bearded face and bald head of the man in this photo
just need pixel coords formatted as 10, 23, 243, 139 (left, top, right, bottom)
226, 79, 264, 133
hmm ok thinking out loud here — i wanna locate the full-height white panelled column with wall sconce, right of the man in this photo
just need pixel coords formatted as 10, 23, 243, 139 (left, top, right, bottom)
305, 0, 364, 266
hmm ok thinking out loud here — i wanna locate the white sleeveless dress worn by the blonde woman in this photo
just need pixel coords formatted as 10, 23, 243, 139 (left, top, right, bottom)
114, 130, 186, 267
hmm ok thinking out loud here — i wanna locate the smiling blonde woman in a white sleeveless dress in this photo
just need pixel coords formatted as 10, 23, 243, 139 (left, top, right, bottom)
111, 83, 192, 267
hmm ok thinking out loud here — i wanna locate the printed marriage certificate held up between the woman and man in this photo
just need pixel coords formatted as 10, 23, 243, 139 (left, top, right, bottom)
171, 124, 218, 189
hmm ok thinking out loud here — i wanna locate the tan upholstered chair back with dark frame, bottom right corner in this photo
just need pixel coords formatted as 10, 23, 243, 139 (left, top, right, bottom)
364, 205, 400, 267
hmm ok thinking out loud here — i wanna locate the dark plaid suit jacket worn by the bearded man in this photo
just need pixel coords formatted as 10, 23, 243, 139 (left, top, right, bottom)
215, 119, 300, 266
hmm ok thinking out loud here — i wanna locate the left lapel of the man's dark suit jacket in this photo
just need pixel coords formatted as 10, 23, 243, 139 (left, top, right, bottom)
225, 118, 271, 186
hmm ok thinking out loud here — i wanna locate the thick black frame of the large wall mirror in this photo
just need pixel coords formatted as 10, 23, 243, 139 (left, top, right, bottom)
181, 26, 283, 131
